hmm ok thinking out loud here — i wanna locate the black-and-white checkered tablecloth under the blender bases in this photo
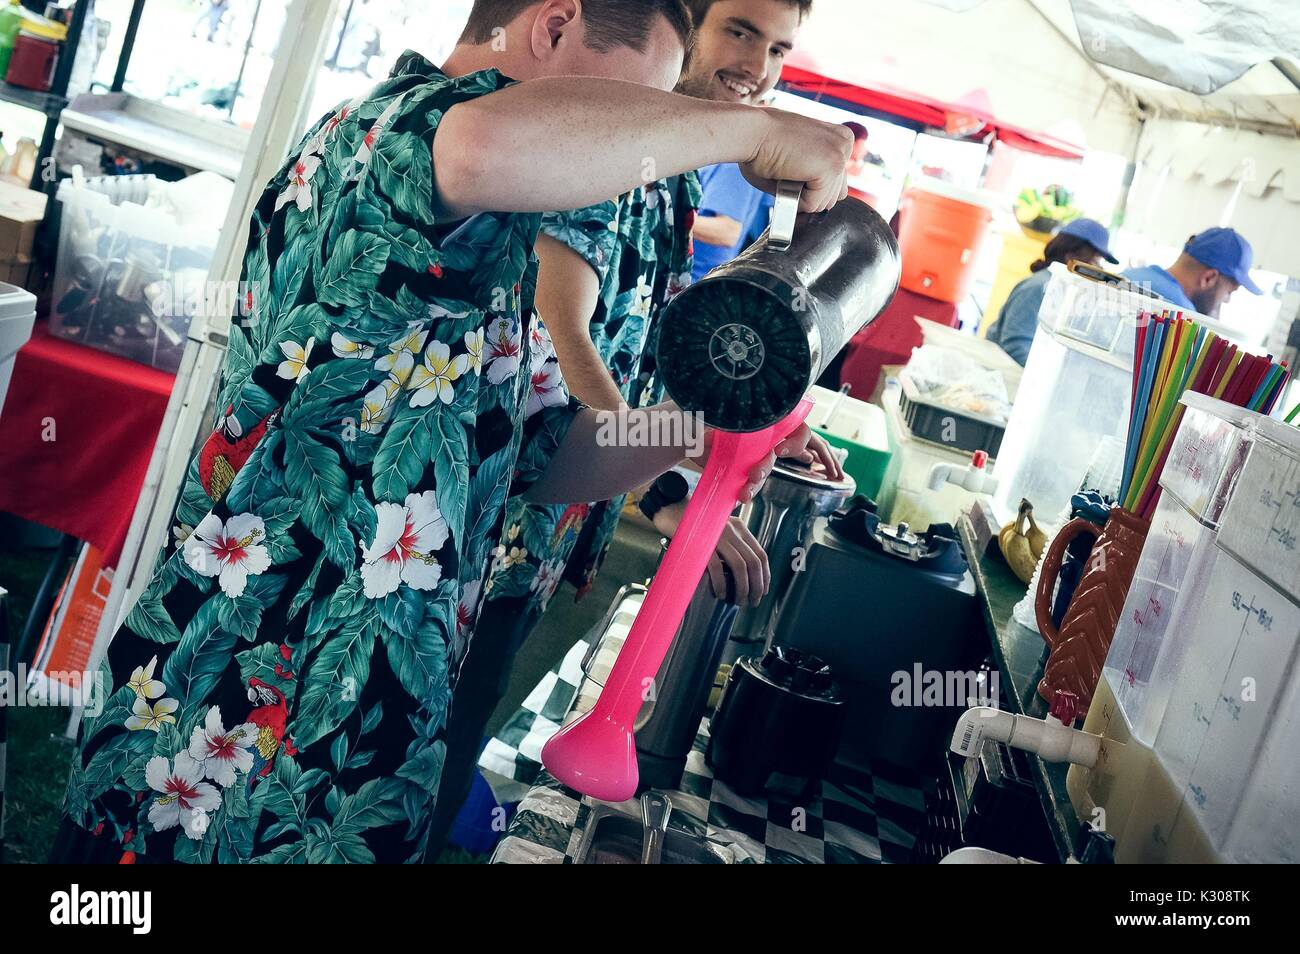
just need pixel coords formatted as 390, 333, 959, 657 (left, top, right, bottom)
478, 594, 933, 864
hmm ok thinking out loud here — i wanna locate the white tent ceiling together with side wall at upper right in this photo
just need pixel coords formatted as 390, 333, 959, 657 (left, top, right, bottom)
792, 0, 1300, 276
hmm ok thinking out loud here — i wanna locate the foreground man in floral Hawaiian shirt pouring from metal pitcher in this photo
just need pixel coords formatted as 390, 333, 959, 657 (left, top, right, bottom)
53, 0, 849, 863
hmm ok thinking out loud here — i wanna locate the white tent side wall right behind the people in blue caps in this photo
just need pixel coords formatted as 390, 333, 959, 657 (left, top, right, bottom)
1127, 120, 1300, 276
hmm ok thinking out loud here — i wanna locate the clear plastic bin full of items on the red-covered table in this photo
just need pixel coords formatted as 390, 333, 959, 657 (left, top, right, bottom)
49, 175, 217, 372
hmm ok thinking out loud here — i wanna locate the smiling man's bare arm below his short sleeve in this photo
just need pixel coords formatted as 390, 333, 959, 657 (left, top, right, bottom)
536, 234, 623, 411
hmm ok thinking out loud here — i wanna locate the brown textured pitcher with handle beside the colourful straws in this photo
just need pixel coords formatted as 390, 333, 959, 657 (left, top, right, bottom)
1034, 507, 1151, 712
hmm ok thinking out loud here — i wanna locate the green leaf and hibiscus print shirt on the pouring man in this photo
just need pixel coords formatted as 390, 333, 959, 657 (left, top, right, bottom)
55, 53, 573, 863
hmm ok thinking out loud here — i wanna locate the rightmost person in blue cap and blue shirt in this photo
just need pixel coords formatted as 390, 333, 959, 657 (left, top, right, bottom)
1123, 229, 1260, 318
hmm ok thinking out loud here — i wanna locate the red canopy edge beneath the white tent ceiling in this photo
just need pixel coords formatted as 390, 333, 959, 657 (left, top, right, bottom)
781, 56, 1083, 159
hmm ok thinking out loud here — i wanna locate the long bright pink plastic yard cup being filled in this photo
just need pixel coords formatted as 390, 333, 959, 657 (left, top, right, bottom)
542, 398, 813, 802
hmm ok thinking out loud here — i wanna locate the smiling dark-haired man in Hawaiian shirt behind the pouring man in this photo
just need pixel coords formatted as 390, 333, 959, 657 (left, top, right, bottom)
430, 0, 842, 850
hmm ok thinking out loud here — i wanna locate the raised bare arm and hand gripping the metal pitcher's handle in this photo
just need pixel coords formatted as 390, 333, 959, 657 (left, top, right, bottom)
433, 77, 853, 218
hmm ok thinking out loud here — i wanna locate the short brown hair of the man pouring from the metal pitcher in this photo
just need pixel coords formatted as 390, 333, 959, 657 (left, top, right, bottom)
460, 0, 696, 53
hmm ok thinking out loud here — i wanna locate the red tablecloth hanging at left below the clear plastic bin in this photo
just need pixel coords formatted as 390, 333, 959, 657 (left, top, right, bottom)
0, 321, 176, 565
